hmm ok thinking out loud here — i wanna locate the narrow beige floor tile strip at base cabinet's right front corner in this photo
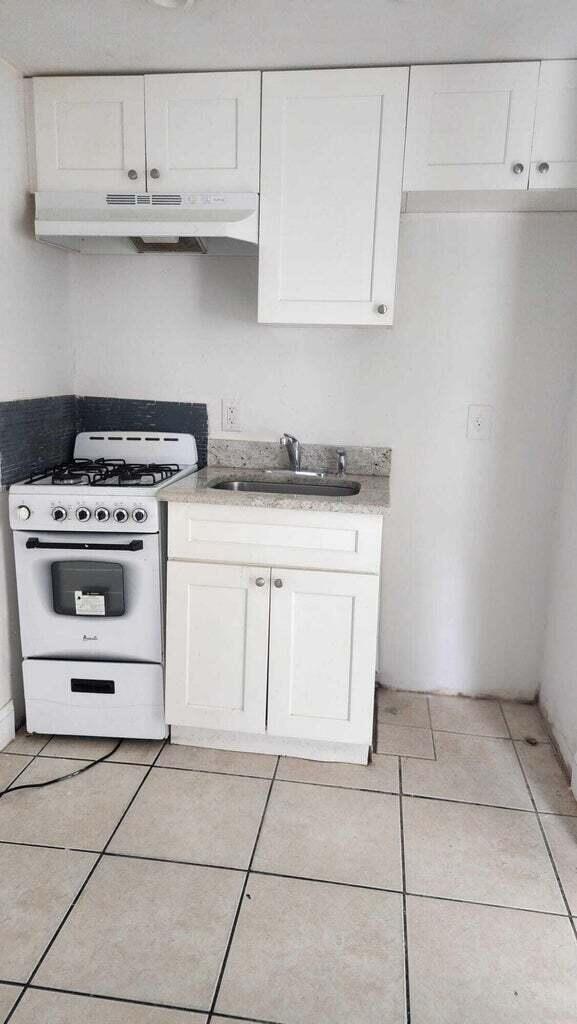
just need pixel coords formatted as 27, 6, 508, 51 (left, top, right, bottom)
277, 754, 399, 793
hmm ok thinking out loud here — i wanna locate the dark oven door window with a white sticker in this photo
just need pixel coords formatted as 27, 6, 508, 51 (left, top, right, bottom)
52, 559, 124, 616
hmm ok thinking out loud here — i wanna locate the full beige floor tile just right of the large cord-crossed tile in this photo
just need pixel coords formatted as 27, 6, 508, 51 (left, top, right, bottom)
110, 768, 271, 867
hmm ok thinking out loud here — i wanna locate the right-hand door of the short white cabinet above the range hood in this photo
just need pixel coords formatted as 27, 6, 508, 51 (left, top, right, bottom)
146, 71, 260, 193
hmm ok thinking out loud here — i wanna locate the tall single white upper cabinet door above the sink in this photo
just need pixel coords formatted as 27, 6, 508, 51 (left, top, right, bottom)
258, 68, 408, 325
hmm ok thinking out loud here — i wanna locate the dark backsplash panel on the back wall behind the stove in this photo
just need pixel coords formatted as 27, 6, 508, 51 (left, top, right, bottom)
77, 396, 208, 467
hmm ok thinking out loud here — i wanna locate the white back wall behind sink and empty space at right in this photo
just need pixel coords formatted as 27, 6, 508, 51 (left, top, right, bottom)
72, 214, 577, 697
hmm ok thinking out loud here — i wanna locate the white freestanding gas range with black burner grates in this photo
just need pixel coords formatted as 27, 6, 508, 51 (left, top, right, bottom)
9, 430, 198, 738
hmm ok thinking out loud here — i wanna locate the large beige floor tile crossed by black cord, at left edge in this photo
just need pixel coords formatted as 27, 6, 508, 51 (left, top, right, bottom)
0, 758, 147, 850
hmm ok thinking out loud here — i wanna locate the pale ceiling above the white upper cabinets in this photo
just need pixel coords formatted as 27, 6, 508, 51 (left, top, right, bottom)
0, 0, 577, 75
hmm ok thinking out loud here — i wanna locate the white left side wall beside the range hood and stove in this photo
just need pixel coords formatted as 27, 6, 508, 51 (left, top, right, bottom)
0, 61, 73, 710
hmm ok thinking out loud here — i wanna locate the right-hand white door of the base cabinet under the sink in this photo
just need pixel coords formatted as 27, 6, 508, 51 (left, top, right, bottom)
267, 569, 378, 743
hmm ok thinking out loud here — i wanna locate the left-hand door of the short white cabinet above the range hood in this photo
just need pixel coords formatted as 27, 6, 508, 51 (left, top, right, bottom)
33, 76, 146, 191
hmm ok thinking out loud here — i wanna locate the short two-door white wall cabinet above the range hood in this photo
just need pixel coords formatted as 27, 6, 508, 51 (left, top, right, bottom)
32, 72, 260, 193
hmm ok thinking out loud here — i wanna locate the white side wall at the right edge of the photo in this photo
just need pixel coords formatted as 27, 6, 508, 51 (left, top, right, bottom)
540, 378, 577, 785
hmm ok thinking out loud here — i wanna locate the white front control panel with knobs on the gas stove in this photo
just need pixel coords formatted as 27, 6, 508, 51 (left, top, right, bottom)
9, 487, 161, 534
